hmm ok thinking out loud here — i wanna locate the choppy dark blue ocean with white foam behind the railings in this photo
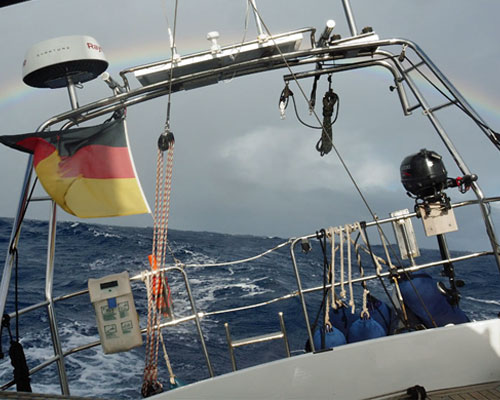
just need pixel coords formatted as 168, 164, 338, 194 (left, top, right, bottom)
0, 218, 500, 399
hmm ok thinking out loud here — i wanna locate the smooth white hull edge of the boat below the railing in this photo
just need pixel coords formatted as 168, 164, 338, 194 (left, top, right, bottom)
154, 319, 500, 400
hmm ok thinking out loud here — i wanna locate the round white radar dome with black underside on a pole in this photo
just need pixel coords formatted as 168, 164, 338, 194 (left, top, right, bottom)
23, 35, 108, 89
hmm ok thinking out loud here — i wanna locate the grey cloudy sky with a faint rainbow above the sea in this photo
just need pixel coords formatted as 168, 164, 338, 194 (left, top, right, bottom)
0, 0, 500, 249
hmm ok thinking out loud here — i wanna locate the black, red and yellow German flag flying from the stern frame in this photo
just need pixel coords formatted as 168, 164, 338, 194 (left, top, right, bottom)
0, 119, 151, 218
